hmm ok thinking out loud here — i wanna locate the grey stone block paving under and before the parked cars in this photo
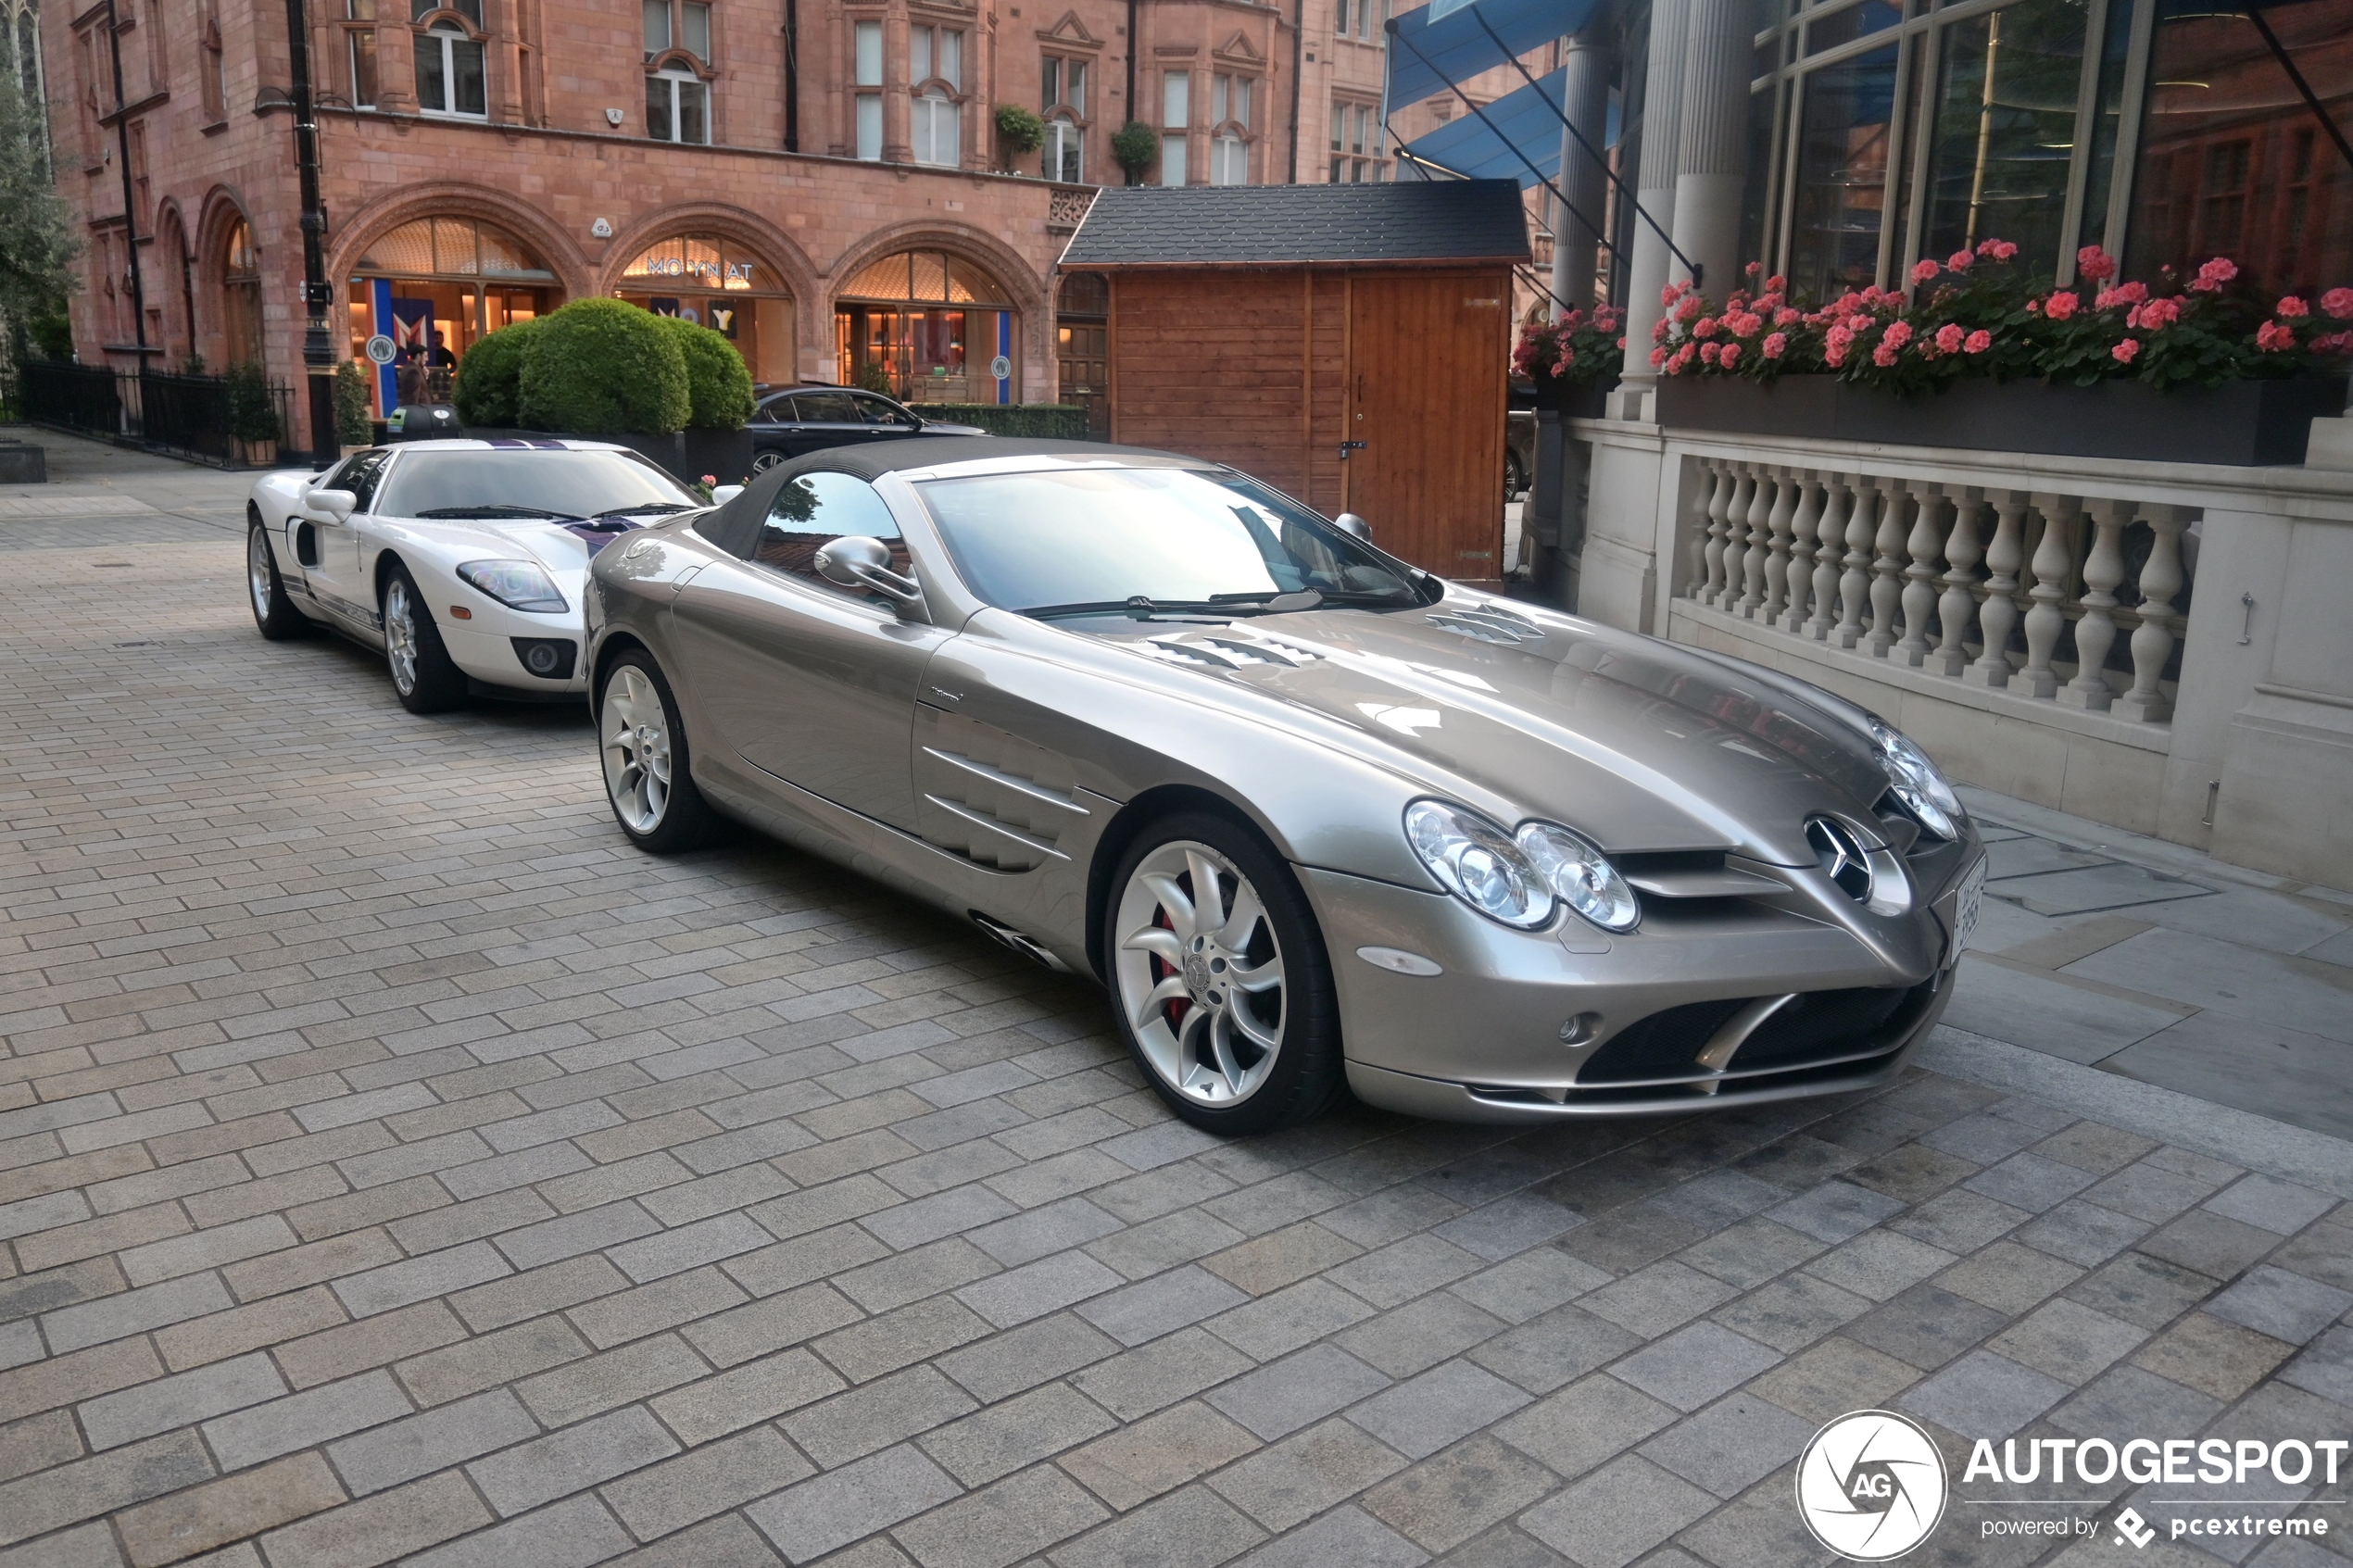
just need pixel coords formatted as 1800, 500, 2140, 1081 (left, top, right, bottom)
0, 433, 2353, 1568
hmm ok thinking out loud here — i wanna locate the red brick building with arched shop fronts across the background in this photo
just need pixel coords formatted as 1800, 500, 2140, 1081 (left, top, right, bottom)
43, 0, 1458, 453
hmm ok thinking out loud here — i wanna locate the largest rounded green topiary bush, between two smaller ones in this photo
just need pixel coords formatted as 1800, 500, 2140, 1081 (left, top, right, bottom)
517, 298, 694, 435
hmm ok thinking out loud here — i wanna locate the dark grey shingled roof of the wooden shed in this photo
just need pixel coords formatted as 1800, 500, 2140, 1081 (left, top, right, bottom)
1062, 179, 1529, 268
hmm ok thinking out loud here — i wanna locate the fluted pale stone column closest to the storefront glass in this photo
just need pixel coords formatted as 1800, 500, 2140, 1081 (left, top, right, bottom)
1673, 0, 1755, 301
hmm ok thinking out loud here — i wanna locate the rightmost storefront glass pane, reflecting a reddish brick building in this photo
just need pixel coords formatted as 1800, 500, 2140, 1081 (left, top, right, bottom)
2127, 0, 2353, 294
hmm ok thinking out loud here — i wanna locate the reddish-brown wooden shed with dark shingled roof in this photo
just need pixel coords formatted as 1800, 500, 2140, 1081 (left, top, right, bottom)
1062, 179, 1529, 578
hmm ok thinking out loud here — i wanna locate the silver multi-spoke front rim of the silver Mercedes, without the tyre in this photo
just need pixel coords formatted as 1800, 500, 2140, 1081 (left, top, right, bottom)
1113, 839, 1287, 1108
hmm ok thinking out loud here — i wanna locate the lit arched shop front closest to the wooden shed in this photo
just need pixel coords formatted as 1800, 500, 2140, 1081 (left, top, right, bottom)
833, 252, 1021, 402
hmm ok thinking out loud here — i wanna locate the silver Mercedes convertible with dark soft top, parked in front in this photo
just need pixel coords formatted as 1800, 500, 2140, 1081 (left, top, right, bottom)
585, 437, 1986, 1133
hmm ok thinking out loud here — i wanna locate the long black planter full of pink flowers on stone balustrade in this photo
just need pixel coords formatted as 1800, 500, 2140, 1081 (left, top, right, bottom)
1650, 240, 2353, 466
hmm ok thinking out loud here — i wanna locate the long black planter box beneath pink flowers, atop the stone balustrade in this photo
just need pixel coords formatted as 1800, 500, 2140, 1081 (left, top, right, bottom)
1659, 374, 2346, 468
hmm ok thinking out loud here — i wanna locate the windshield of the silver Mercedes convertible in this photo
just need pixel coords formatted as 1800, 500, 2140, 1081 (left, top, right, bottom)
920, 468, 1421, 613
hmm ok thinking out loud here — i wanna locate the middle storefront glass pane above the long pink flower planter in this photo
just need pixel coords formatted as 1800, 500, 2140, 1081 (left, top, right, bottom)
1916, 0, 2084, 270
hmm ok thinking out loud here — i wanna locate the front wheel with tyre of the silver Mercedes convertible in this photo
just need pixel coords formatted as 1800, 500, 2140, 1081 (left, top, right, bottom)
1101, 813, 1343, 1133
